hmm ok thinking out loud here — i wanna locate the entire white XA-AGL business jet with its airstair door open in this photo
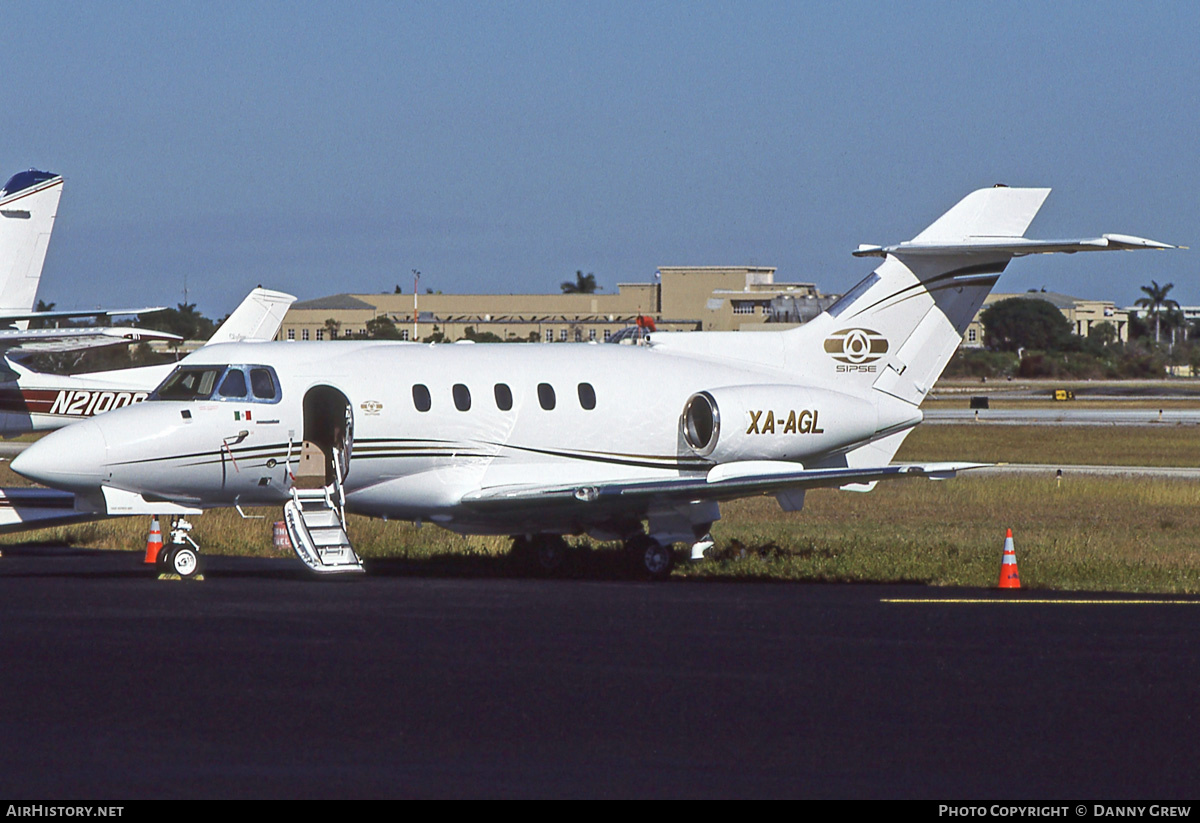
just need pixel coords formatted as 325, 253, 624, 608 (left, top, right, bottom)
4, 187, 1174, 577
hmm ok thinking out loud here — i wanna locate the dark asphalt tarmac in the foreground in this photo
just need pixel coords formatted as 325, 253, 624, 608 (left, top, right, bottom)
0, 548, 1200, 800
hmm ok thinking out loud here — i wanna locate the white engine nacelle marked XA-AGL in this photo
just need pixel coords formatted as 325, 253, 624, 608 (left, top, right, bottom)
679, 385, 878, 463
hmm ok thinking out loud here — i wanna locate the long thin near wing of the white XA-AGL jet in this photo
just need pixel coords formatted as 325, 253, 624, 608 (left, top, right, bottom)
462, 461, 990, 510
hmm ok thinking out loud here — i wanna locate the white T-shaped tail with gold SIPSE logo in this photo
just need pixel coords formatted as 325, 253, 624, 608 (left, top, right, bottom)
786, 186, 1175, 475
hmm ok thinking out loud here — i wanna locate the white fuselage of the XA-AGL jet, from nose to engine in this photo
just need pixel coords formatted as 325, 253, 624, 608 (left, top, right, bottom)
14, 335, 920, 533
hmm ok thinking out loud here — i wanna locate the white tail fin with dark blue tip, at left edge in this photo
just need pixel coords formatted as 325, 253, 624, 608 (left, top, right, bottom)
0, 169, 62, 313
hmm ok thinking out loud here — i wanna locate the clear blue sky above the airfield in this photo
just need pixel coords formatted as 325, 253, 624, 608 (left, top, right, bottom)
0, 0, 1200, 316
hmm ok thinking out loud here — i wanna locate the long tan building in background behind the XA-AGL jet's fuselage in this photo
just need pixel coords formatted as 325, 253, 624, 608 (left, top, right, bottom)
278, 266, 838, 343
